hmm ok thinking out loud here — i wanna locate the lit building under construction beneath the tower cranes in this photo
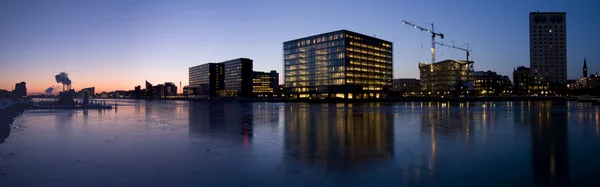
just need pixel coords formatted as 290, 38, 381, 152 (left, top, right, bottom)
419, 60, 475, 95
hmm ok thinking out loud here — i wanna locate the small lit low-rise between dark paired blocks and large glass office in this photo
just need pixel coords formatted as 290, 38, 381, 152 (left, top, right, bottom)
252, 70, 279, 97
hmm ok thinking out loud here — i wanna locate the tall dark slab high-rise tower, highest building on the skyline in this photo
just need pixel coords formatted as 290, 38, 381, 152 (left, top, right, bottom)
529, 12, 567, 85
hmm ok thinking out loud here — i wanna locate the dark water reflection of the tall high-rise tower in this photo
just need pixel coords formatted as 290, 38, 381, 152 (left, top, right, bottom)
531, 101, 569, 186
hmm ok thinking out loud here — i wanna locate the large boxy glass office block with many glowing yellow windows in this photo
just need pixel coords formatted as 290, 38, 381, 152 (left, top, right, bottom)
283, 30, 393, 99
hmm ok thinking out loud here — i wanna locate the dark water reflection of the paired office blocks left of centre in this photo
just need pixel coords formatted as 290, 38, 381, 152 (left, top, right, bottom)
189, 101, 253, 145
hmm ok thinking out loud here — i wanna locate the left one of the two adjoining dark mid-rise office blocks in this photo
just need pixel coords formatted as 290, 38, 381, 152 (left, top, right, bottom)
188, 63, 224, 97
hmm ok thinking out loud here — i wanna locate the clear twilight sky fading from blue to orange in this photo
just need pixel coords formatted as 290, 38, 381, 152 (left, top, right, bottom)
0, 0, 600, 94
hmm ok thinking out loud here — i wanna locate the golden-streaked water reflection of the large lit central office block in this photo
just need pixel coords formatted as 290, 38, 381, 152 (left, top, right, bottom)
285, 103, 394, 166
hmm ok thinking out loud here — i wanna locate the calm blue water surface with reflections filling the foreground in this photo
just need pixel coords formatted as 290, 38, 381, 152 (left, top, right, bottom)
0, 100, 600, 187
